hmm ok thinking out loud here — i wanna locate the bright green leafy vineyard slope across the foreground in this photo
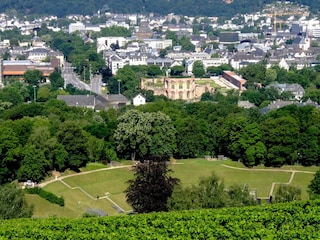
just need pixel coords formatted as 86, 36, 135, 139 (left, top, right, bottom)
0, 201, 320, 240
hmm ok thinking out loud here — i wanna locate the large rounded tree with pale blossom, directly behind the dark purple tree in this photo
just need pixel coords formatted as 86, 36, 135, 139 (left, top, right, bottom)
114, 110, 176, 160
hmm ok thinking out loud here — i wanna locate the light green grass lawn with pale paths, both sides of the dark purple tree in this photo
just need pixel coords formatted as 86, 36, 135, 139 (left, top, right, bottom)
27, 159, 318, 217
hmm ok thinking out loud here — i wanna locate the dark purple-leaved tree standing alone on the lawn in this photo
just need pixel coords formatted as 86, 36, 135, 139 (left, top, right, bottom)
125, 161, 179, 213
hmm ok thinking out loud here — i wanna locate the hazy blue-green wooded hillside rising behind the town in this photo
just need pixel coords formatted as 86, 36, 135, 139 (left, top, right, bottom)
0, 0, 320, 17
